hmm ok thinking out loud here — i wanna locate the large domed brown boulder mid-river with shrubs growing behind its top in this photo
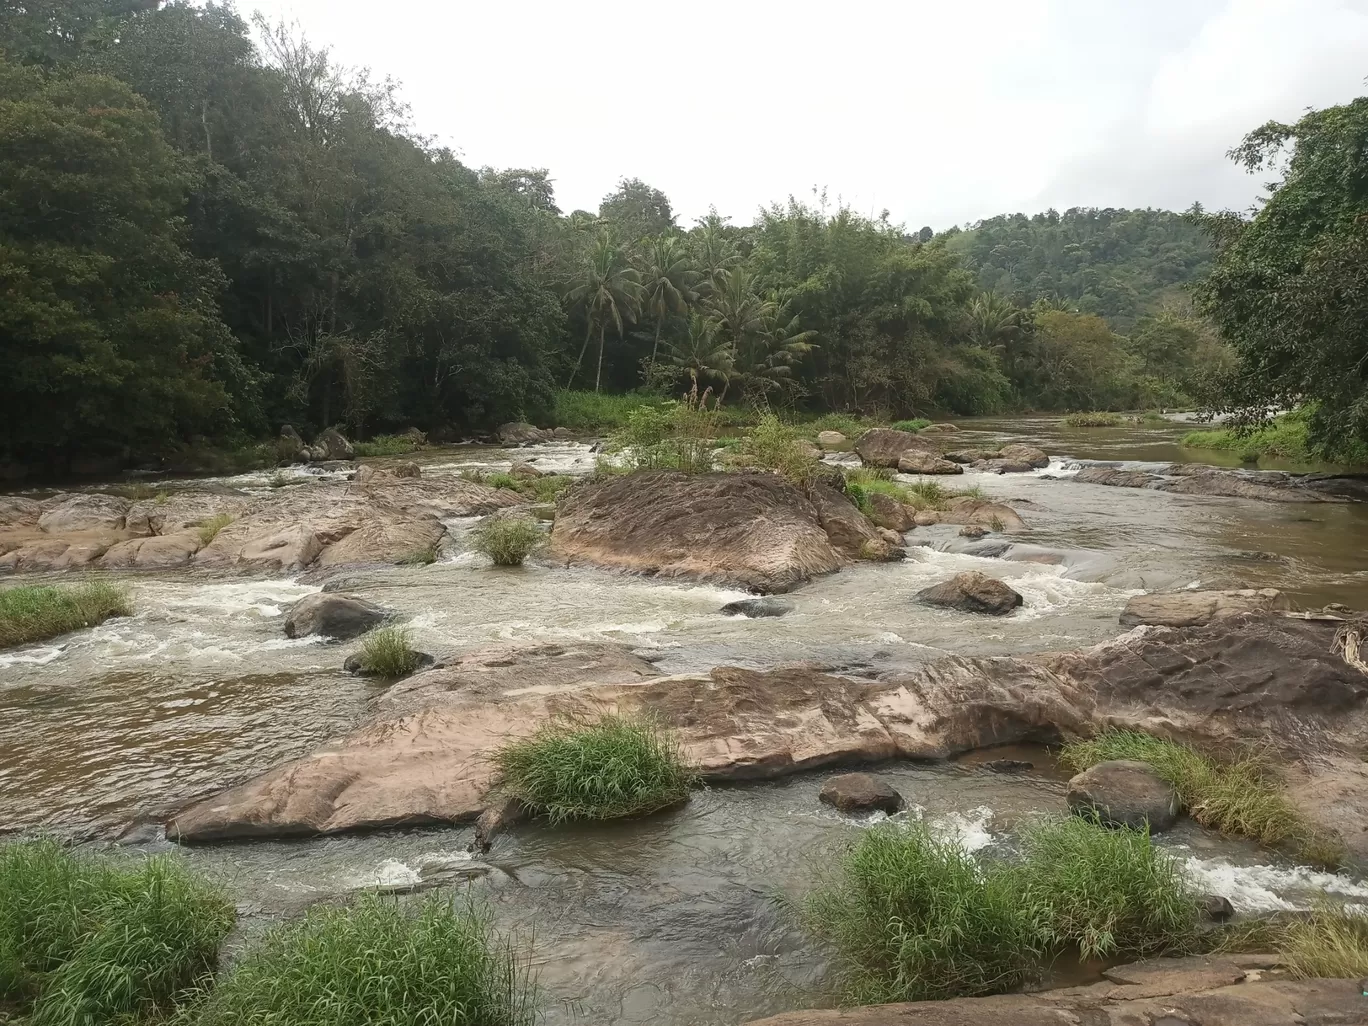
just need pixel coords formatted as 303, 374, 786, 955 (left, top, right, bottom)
551, 471, 848, 592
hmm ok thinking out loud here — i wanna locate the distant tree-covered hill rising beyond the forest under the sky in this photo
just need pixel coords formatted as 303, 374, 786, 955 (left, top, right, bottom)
947, 207, 1211, 332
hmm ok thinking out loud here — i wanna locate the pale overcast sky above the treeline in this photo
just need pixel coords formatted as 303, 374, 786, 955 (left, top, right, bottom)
238, 0, 1368, 230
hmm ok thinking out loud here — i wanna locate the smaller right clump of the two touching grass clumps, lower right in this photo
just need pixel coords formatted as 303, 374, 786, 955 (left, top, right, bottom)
1019, 815, 1197, 959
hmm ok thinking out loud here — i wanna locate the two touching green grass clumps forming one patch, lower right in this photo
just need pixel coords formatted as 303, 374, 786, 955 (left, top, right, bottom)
802, 817, 1197, 1004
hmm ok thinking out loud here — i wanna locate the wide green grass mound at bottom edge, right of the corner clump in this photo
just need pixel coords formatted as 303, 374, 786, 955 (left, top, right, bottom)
197, 895, 536, 1026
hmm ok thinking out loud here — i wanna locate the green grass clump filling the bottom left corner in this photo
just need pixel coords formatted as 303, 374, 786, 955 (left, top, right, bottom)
0, 841, 234, 1026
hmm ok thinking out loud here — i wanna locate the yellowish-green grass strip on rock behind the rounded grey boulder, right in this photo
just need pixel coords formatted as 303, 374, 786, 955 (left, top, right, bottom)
1059, 731, 1343, 866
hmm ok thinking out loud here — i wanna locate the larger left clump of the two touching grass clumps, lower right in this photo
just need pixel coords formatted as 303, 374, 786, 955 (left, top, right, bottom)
802, 822, 1042, 1004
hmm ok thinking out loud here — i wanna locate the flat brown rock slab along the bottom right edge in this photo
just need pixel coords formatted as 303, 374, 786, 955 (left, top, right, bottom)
750, 955, 1365, 1026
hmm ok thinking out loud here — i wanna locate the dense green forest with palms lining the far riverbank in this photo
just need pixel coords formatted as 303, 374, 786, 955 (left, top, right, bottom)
0, 0, 1362, 472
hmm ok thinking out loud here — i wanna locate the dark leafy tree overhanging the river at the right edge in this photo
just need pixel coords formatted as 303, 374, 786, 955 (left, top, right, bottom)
1192, 97, 1368, 453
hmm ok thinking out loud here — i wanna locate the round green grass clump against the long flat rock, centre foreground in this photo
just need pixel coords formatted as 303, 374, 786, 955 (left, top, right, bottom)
495, 715, 694, 824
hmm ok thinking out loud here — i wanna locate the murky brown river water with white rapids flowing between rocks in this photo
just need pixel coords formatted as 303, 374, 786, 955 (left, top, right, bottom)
0, 419, 1368, 1026
